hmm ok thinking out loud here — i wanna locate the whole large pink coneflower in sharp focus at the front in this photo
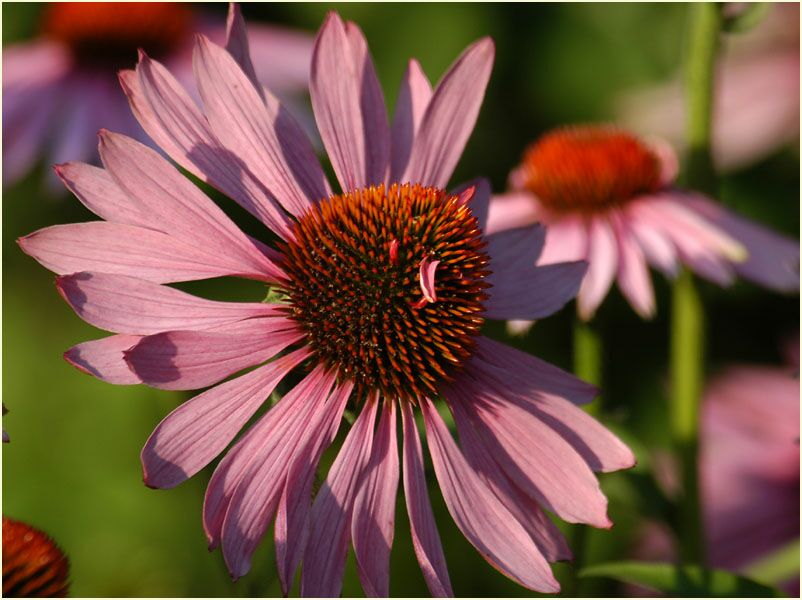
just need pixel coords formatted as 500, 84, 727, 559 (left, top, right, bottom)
20, 9, 634, 596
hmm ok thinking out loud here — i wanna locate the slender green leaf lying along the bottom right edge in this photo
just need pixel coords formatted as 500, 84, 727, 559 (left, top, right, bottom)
579, 561, 783, 598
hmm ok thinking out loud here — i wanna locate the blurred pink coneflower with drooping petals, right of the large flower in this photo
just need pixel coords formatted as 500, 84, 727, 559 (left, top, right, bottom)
488, 125, 799, 319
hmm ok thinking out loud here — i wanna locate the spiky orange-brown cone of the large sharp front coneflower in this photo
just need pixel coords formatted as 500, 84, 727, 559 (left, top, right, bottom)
282, 184, 490, 401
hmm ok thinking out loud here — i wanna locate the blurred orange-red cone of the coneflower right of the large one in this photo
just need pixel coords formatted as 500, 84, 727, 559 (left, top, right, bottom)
522, 125, 662, 212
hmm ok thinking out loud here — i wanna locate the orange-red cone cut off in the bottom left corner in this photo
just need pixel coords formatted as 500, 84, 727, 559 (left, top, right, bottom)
3, 517, 70, 598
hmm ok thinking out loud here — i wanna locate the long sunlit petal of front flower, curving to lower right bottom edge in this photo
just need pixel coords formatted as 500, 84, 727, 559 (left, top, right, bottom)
421, 399, 560, 593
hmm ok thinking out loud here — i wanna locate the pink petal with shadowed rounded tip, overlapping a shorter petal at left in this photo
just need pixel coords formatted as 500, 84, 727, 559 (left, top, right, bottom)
124, 317, 304, 390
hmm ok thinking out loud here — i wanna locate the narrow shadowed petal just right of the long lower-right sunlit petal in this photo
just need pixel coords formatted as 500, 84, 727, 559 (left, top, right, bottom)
446, 388, 568, 562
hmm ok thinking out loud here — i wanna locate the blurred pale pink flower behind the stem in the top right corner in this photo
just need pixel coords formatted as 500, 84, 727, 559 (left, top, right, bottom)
618, 2, 799, 171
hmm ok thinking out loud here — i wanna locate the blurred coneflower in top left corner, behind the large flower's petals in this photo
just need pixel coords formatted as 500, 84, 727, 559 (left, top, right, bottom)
3, 2, 312, 184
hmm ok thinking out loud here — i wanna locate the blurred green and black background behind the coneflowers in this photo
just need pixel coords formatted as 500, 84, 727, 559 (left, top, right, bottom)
2, 3, 800, 596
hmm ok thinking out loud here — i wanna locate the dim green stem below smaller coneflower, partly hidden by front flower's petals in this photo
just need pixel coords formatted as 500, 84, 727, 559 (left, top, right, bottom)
564, 318, 602, 597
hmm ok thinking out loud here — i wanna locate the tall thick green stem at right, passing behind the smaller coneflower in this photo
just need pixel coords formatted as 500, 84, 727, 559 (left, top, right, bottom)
670, 3, 721, 564
